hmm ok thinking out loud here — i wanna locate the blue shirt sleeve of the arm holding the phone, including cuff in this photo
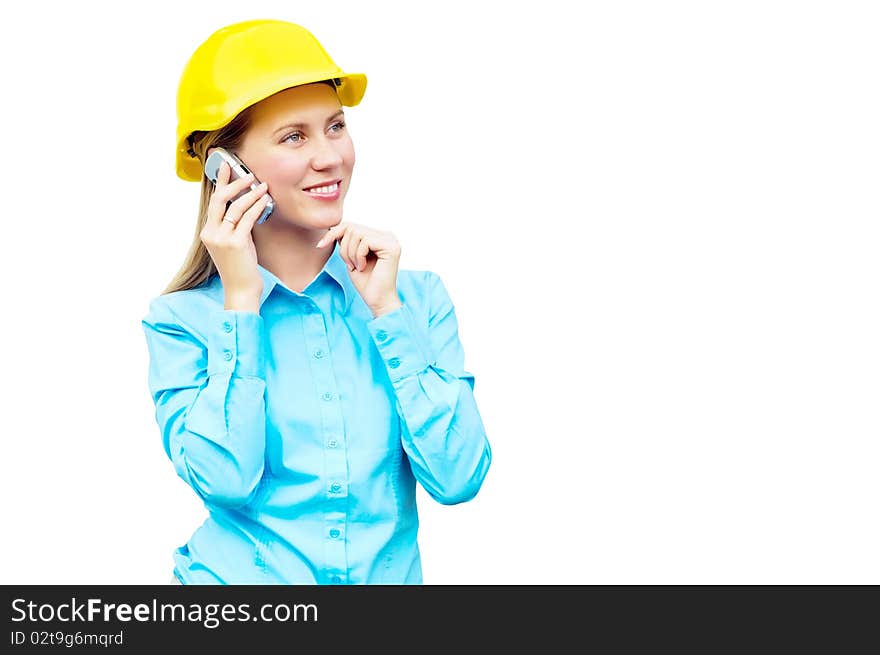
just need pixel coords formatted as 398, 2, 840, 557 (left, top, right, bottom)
141, 296, 266, 507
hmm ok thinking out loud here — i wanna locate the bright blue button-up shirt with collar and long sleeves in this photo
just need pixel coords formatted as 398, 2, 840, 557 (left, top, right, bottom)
142, 243, 491, 584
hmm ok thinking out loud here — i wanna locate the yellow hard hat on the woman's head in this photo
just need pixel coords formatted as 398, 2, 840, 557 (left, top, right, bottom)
177, 20, 367, 182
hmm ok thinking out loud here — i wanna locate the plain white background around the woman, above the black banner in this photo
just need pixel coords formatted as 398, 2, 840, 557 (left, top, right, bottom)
0, 0, 880, 584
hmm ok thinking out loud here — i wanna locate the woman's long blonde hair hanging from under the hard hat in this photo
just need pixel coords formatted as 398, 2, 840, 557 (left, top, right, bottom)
161, 80, 336, 295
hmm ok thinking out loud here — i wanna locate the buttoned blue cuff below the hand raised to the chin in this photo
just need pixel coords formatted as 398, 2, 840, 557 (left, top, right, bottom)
367, 304, 436, 382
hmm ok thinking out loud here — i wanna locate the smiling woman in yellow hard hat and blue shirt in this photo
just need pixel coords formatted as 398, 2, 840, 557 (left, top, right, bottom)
142, 20, 491, 584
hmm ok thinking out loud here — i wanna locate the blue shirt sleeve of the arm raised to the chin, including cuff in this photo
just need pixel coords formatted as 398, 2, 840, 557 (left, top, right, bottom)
367, 272, 492, 505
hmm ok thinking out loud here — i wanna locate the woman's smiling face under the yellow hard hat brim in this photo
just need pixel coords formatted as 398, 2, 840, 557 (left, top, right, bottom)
236, 83, 354, 230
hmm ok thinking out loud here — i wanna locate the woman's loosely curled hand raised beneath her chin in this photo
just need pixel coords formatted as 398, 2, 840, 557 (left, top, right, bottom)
315, 221, 402, 317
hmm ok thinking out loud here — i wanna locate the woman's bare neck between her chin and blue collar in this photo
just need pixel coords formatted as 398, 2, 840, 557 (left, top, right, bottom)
251, 218, 335, 293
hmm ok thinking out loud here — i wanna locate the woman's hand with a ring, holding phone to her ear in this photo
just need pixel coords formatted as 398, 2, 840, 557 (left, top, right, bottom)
199, 162, 269, 299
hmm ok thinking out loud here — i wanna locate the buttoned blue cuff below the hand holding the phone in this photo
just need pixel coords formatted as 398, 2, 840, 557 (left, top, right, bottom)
208, 309, 266, 380
